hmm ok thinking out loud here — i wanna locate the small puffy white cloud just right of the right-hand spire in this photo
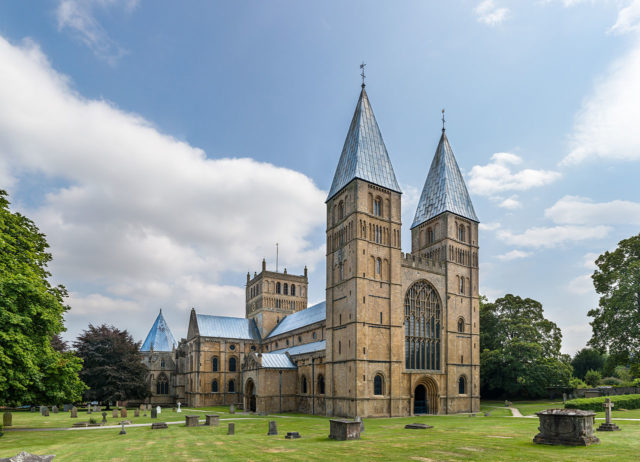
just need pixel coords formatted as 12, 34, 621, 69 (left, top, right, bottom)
468, 152, 561, 196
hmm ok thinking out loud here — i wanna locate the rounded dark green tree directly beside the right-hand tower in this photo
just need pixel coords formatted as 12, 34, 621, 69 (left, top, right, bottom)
480, 294, 571, 398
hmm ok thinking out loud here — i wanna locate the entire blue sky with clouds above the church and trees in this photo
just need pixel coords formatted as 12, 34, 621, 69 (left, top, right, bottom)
0, 0, 640, 354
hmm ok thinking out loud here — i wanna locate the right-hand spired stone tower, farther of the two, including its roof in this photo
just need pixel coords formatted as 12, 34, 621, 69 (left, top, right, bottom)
411, 128, 480, 412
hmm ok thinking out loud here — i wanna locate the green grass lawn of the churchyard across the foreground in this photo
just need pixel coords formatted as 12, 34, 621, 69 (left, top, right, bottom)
0, 402, 640, 462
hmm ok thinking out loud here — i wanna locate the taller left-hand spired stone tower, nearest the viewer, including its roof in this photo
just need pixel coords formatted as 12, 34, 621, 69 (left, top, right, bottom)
326, 84, 403, 416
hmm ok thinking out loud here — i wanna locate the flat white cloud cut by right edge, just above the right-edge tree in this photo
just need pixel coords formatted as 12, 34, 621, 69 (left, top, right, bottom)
544, 196, 640, 226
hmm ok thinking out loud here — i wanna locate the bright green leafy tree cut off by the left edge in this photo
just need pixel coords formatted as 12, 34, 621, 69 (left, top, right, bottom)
0, 190, 86, 405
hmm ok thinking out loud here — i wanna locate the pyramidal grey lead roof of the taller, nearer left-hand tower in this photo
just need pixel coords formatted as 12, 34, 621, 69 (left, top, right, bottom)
327, 85, 401, 200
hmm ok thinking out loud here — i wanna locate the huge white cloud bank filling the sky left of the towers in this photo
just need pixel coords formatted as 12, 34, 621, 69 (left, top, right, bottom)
0, 37, 326, 337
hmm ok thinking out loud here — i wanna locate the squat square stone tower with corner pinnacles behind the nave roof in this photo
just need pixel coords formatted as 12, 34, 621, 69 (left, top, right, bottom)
245, 259, 309, 338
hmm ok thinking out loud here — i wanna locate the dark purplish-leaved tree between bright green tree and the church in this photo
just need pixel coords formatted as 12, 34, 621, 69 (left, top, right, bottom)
73, 324, 150, 405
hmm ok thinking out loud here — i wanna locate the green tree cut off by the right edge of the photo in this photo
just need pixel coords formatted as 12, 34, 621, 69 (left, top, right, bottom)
588, 234, 640, 371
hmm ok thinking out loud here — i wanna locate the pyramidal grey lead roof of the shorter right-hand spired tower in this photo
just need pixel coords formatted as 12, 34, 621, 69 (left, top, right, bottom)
411, 129, 480, 228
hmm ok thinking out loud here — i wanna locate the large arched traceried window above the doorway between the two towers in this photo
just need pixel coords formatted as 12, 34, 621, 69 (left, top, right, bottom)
404, 281, 442, 370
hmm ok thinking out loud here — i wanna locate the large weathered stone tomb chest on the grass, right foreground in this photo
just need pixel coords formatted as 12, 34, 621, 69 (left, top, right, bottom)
533, 409, 600, 446
